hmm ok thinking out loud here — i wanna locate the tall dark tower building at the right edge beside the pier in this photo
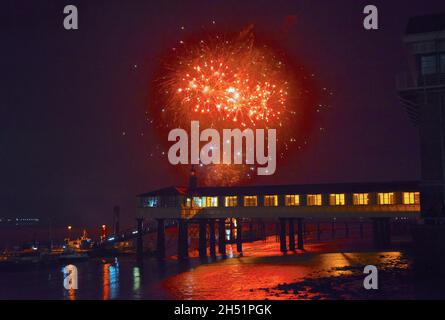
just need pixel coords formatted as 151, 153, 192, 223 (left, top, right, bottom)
398, 13, 445, 223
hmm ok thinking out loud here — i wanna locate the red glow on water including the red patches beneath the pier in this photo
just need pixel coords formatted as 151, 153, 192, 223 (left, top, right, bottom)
162, 237, 400, 300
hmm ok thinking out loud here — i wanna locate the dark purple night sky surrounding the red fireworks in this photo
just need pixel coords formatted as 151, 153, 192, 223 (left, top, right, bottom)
0, 0, 445, 229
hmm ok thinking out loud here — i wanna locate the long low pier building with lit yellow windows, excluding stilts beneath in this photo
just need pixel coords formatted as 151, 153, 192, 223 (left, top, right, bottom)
138, 181, 420, 219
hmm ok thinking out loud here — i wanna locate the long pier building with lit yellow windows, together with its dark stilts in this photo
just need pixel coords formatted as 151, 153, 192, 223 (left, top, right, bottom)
138, 170, 420, 258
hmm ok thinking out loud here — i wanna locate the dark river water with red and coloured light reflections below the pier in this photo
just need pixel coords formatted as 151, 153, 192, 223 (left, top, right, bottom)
0, 239, 445, 300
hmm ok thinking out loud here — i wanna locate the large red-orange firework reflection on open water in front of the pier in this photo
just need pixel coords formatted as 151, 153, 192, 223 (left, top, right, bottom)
163, 252, 403, 300
